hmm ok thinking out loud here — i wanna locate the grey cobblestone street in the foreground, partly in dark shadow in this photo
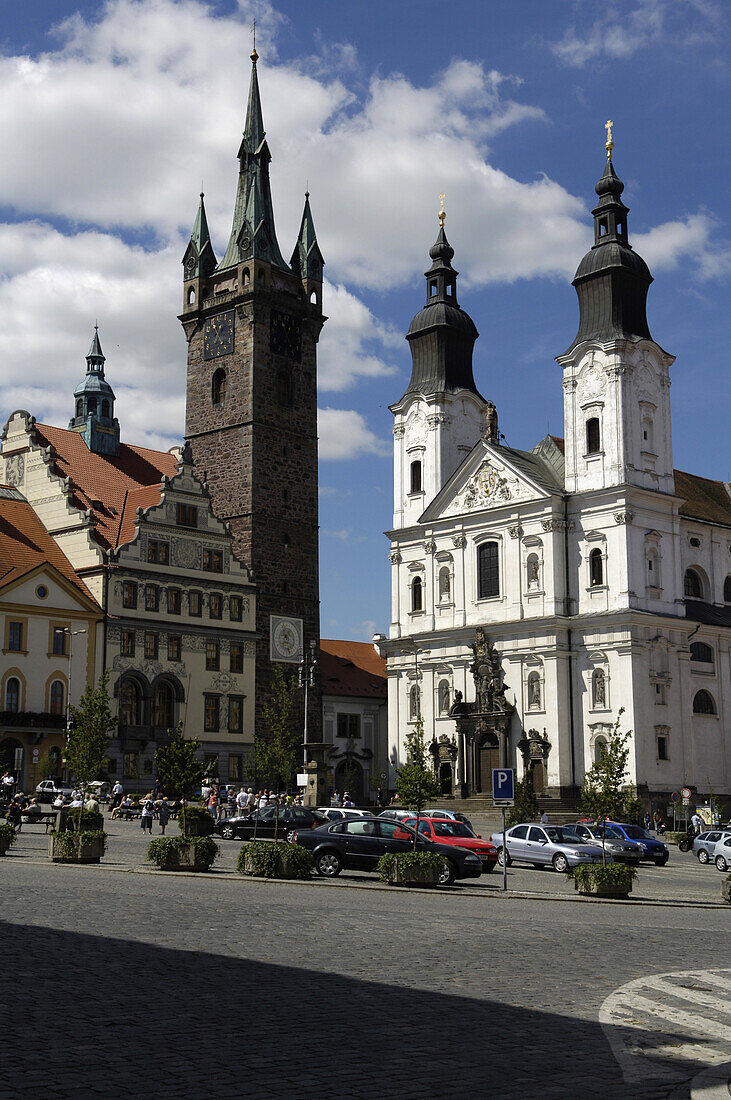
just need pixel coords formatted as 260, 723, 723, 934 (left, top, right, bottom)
0, 826, 731, 1100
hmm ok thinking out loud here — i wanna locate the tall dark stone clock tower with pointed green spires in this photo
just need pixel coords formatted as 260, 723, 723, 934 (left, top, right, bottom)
180, 51, 325, 740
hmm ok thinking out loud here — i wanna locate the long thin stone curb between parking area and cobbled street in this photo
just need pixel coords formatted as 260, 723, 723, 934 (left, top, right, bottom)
7, 859, 731, 910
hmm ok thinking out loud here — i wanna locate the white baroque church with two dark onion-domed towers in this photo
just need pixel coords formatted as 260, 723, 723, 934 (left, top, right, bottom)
377, 134, 731, 812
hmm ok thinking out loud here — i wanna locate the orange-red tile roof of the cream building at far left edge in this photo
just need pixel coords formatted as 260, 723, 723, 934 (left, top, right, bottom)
0, 485, 101, 614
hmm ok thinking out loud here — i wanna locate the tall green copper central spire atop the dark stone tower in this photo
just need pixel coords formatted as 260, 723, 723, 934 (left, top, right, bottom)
218, 53, 289, 271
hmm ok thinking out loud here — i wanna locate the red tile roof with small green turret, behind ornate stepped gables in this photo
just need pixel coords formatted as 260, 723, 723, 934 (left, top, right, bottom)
35, 424, 177, 549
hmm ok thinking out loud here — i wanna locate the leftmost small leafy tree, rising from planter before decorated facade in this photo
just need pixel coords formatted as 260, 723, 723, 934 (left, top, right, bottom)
64, 672, 117, 850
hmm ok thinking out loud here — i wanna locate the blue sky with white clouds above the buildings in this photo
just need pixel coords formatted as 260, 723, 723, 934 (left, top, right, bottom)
0, 0, 731, 638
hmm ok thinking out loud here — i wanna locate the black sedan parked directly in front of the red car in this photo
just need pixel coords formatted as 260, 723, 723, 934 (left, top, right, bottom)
293, 817, 483, 886
